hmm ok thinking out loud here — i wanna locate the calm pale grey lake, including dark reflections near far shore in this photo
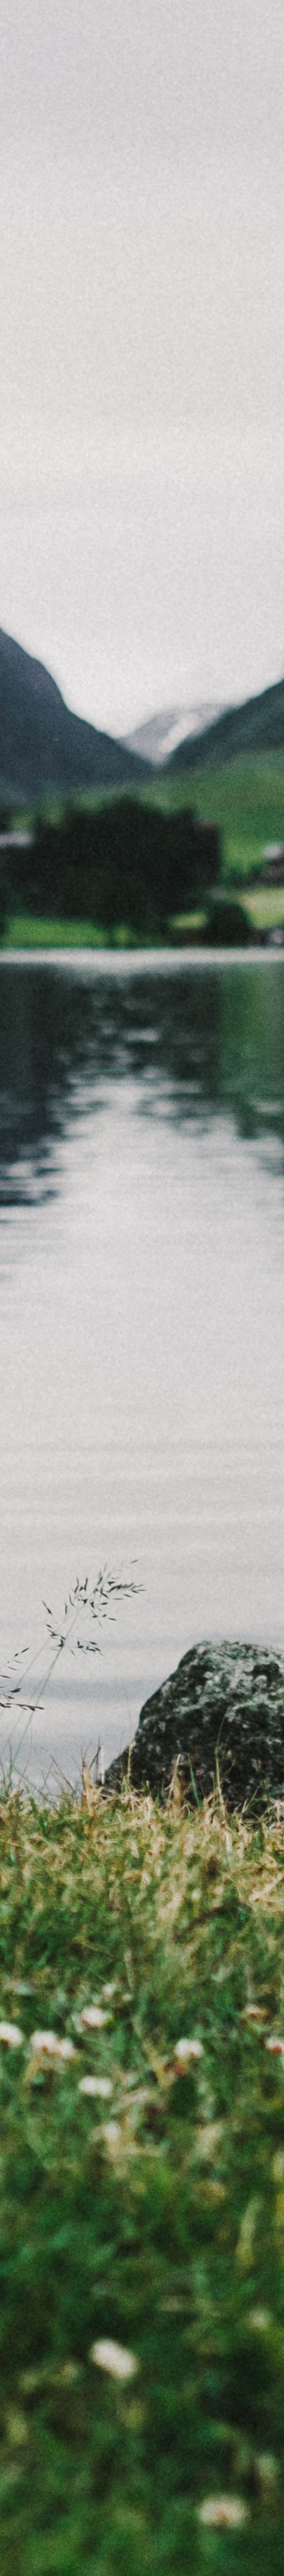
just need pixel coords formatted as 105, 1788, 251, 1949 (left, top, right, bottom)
0, 953, 284, 1780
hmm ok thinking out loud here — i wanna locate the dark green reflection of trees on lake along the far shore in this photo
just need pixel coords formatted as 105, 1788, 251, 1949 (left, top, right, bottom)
0, 961, 284, 1200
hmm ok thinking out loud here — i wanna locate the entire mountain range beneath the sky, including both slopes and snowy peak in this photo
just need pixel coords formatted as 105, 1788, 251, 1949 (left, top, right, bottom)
0, 629, 284, 804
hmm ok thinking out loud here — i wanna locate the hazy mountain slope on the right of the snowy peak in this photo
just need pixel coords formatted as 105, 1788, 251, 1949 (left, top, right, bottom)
168, 680, 284, 773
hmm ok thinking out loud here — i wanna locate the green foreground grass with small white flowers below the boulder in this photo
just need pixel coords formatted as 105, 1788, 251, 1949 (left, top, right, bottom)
0, 1772, 284, 2576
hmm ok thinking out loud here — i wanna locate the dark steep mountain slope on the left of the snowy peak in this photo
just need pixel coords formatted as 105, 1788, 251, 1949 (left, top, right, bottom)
0, 629, 144, 798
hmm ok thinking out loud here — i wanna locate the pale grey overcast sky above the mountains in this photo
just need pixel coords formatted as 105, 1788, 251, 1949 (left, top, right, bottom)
0, 0, 284, 732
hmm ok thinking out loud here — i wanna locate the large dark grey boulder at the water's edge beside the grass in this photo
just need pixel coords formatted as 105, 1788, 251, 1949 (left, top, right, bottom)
106, 1643, 284, 1808
